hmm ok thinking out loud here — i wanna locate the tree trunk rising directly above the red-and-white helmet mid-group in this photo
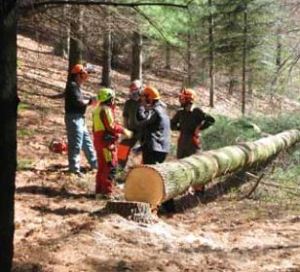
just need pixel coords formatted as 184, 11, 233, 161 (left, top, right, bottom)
131, 32, 143, 81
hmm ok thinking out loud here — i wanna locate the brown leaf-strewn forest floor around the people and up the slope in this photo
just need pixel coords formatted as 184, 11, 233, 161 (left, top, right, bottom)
14, 36, 300, 272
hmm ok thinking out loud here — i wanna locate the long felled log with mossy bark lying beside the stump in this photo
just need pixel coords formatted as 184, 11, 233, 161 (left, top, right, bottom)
125, 130, 300, 207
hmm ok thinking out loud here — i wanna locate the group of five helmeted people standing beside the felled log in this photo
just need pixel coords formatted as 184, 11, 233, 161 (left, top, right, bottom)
65, 64, 215, 206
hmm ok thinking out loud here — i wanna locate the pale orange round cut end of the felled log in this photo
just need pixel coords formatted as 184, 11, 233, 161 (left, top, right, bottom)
125, 166, 165, 208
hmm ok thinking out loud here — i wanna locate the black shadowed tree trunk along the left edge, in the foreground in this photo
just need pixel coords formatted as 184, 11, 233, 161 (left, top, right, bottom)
0, 0, 18, 272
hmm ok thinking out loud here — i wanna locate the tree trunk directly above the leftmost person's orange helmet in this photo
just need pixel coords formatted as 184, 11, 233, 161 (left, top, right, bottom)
69, 6, 83, 71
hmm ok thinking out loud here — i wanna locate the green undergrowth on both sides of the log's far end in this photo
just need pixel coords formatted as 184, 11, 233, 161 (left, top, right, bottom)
202, 113, 300, 202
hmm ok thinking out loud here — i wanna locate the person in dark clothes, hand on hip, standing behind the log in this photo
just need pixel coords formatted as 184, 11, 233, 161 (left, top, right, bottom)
171, 88, 215, 197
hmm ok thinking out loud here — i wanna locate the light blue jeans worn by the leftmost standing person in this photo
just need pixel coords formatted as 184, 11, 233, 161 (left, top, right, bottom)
65, 113, 97, 172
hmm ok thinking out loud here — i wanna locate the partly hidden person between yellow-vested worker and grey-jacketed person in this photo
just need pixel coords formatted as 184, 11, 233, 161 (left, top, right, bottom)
118, 79, 142, 170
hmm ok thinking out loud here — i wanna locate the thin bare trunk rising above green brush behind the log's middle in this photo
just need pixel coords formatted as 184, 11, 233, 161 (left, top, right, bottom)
242, 5, 248, 115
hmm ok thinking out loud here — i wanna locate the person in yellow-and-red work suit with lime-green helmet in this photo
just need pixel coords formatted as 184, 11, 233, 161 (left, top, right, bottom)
93, 88, 133, 199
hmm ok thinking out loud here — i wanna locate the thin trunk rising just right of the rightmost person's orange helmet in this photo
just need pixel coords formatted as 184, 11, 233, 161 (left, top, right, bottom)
208, 0, 215, 107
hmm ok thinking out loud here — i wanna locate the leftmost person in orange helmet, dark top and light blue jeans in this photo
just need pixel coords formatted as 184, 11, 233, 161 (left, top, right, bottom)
65, 64, 97, 175
